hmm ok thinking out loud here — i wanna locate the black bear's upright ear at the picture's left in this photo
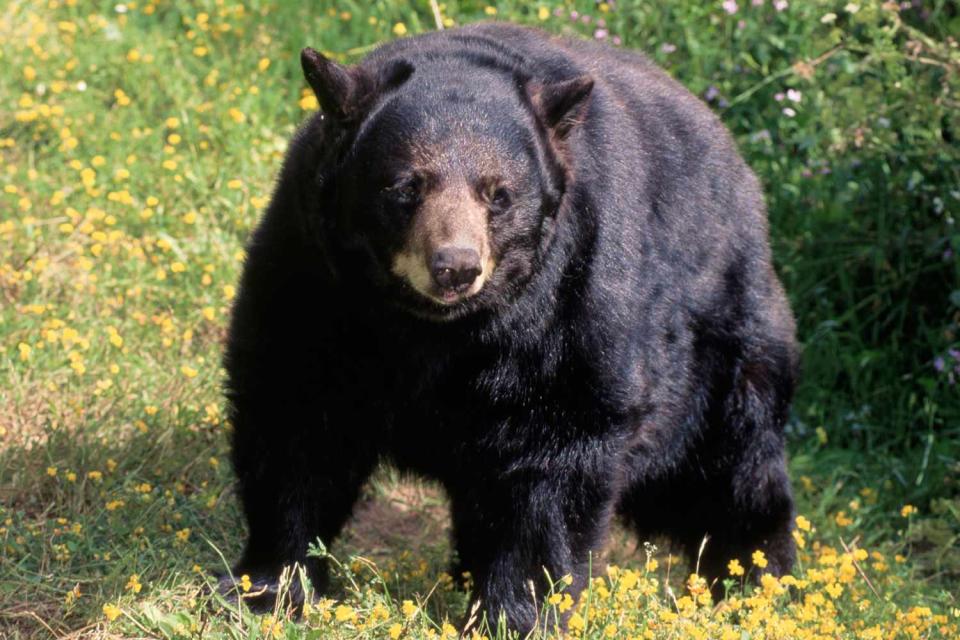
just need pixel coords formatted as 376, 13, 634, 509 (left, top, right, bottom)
300, 47, 413, 122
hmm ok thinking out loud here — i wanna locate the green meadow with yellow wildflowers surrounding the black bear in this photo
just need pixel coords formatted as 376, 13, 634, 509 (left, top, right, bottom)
0, 0, 960, 640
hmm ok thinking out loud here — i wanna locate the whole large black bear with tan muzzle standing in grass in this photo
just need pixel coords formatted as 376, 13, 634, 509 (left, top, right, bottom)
225, 24, 797, 630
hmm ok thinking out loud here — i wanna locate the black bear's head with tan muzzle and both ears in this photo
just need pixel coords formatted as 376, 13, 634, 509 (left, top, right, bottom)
301, 49, 593, 320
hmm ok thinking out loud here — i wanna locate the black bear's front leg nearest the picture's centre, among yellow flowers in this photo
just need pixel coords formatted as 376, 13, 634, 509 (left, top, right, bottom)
452, 456, 613, 633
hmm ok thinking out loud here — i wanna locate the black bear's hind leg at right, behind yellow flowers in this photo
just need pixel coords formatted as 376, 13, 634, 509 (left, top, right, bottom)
619, 343, 795, 598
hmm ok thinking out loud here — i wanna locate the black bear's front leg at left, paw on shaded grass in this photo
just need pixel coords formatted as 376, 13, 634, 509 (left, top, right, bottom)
221, 398, 376, 611
